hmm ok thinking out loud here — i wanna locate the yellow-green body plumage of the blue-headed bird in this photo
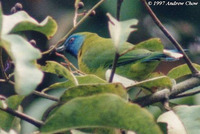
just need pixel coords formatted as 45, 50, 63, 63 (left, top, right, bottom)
78, 32, 163, 80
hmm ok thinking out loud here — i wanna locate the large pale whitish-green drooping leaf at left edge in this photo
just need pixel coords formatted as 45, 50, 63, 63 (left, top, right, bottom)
0, 35, 43, 95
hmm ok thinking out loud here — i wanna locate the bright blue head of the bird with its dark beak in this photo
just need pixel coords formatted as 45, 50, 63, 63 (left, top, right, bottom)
56, 34, 85, 57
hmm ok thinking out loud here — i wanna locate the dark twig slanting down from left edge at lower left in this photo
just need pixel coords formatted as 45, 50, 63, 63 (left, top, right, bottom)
0, 107, 44, 127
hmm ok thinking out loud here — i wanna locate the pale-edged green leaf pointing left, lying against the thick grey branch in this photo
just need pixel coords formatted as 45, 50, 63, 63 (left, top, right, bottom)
129, 76, 173, 93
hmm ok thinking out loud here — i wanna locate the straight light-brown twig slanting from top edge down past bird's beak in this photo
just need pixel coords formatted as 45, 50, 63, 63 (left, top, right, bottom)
42, 0, 105, 55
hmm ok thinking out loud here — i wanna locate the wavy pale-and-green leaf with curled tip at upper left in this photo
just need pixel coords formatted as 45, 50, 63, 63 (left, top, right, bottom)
2, 11, 57, 39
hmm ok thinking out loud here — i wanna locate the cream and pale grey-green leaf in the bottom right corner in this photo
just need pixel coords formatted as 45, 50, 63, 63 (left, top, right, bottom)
158, 105, 200, 134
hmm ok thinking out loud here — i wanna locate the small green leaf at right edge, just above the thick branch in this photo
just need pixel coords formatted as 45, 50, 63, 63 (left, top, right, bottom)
167, 63, 200, 79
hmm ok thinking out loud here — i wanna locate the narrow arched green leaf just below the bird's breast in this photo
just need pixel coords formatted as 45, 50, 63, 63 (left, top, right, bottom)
41, 61, 78, 85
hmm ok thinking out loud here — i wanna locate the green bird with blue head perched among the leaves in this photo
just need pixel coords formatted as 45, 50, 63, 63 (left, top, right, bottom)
56, 32, 182, 81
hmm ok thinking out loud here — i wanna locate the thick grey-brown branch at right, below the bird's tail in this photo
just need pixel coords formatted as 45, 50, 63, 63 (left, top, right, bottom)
133, 77, 200, 107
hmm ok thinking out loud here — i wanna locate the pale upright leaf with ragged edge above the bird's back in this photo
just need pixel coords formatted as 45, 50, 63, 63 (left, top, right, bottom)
107, 13, 138, 51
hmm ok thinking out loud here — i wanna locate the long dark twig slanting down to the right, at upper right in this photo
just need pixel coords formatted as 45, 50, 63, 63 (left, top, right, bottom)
141, 0, 199, 76
